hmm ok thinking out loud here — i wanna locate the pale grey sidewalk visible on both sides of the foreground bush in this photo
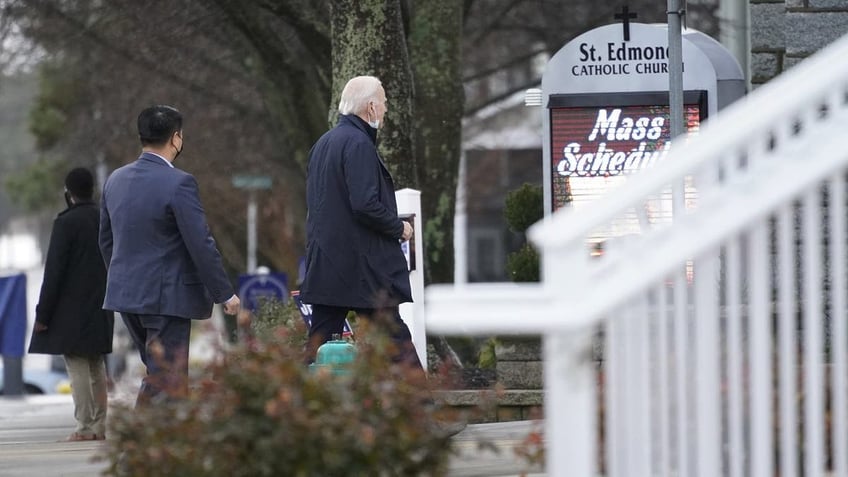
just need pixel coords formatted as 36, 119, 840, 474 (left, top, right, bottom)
0, 395, 544, 477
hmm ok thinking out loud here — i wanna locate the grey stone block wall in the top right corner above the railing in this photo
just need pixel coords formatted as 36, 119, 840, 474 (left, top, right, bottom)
750, 0, 848, 88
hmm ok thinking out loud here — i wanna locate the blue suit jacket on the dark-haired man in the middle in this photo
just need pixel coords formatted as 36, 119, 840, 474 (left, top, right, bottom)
100, 153, 233, 319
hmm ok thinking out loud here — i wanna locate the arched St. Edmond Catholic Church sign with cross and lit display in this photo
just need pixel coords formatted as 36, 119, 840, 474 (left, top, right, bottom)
542, 18, 745, 244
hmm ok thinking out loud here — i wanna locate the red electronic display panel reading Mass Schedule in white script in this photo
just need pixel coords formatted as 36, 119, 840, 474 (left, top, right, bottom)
548, 91, 707, 243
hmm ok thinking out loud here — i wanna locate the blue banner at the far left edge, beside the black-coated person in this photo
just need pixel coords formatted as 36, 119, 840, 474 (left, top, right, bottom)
0, 273, 27, 358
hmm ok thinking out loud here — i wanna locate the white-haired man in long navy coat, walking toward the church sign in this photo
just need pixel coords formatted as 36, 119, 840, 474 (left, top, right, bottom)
301, 76, 421, 367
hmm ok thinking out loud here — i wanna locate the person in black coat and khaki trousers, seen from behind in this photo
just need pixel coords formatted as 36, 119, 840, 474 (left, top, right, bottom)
29, 168, 114, 441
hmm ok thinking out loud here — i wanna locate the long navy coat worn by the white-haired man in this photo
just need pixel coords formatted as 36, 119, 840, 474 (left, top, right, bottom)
300, 115, 412, 308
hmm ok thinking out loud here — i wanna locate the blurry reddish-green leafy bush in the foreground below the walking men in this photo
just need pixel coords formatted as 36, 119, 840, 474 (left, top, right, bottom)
102, 305, 468, 477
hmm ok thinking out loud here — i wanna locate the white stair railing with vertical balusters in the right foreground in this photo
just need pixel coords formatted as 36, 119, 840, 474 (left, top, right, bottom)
426, 31, 848, 477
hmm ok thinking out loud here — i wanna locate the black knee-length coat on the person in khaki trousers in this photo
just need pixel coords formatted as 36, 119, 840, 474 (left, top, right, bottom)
29, 202, 114, 356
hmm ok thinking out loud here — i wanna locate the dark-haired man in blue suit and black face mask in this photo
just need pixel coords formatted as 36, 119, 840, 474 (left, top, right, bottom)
100, 106, 240, 405
